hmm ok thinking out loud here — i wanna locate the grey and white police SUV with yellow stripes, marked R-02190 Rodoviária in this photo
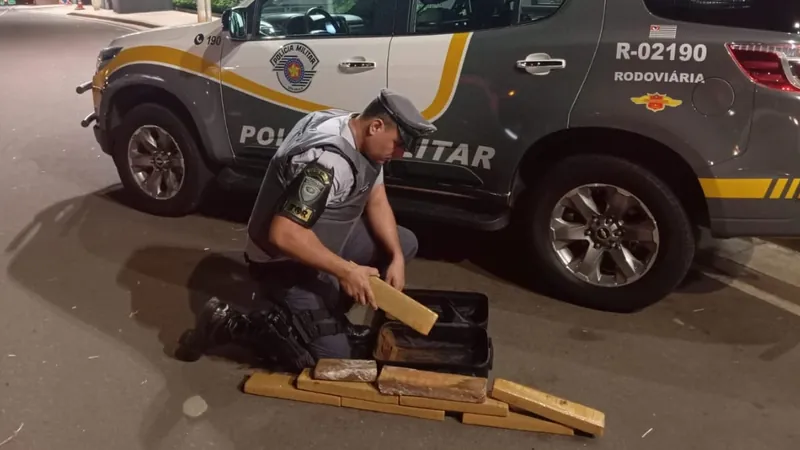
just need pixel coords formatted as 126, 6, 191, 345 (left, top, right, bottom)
78, 0, 800, 311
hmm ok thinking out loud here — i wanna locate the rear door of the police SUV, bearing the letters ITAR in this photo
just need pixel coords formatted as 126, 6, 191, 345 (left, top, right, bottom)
386, 0, 605, 195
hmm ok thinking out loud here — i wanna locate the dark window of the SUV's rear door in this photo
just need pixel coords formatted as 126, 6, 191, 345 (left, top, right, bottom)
413, 0, 564, 34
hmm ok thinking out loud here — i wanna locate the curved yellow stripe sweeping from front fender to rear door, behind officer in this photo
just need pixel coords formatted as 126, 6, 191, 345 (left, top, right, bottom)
93, 33, 470, 118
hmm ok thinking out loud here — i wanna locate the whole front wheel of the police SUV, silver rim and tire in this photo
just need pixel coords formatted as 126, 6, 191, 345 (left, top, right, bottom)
113, 103, 213, 216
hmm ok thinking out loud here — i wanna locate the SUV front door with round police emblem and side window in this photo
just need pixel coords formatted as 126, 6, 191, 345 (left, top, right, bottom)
220, 0, 393, 166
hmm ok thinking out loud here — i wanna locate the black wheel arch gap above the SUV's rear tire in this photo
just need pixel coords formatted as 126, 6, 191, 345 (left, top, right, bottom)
510, 127, 709, 226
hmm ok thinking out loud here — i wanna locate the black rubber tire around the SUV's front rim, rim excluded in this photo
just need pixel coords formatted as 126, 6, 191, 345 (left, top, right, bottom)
113, 103, 214, 216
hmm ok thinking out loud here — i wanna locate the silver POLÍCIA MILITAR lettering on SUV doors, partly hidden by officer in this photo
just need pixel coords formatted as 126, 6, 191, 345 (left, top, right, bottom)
239, 125, 496, 170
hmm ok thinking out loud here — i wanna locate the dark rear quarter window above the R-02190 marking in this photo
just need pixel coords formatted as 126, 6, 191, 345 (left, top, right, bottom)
644, 0, 800, 35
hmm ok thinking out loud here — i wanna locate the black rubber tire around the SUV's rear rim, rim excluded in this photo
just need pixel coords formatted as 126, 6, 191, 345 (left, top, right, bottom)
520, 155, 695, 313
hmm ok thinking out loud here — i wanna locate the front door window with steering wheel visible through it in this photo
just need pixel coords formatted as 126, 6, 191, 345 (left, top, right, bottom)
258, 0, 394, 38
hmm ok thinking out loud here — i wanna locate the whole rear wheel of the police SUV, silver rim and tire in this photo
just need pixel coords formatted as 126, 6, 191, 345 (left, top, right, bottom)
524, 155, 695, 312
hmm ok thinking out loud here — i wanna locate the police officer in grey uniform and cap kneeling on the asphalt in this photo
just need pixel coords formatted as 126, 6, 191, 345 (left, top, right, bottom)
184, 89, 436, 371
